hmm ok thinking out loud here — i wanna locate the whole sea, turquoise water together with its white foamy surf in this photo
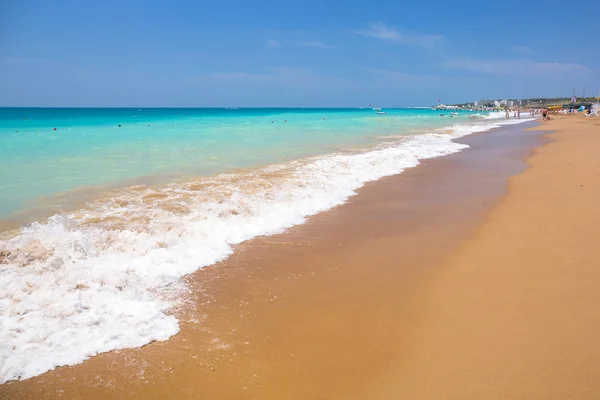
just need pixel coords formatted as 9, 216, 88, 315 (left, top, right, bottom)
0, 108, 527, 383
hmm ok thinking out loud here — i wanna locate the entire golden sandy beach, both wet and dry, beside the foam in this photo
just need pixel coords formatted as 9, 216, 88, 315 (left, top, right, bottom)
0, 120, 600, 399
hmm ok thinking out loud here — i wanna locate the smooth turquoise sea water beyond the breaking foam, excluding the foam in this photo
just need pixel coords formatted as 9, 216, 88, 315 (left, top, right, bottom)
0, 108, 468, 218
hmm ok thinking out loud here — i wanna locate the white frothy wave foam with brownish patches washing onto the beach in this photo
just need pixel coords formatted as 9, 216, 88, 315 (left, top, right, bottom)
0, 120, 536, 382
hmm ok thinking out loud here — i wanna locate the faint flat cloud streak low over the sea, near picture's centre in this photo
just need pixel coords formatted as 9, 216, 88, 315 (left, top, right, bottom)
207, 67, 318, 83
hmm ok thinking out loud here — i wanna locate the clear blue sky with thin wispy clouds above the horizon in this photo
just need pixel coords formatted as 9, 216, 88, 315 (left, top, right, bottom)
0, 0, 600, 107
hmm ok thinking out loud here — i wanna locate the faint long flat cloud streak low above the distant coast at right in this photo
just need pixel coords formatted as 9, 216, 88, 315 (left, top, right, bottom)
443, 58, 589, 77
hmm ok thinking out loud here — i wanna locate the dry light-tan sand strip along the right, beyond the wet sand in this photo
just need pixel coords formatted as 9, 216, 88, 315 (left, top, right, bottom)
371, 116, 600, 400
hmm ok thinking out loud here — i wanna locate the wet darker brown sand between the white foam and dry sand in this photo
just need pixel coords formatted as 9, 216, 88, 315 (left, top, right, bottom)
2, 119, 560, 398
